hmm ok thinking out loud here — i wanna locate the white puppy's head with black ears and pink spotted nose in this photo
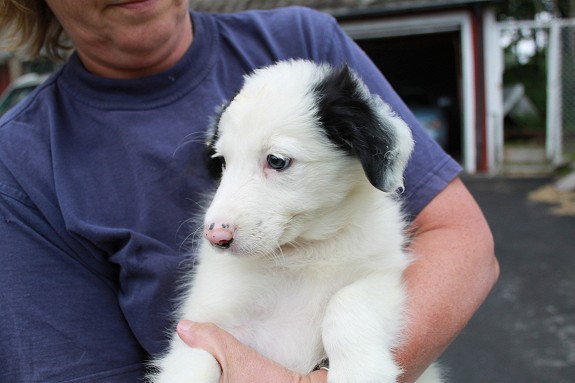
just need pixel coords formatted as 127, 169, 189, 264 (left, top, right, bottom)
205, 60, 413, 255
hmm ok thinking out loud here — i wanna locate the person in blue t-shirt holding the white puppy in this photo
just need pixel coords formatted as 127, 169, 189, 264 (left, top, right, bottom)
0, 0, 498, 383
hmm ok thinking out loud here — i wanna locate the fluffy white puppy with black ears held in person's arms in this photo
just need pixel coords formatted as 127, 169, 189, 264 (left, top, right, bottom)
150, 60, 440, 383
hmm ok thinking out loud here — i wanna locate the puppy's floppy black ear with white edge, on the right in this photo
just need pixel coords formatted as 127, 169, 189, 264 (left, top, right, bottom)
314, 66, 413, 192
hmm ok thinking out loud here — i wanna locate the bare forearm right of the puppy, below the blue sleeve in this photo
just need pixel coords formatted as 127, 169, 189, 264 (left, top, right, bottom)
396, 180, 499, 383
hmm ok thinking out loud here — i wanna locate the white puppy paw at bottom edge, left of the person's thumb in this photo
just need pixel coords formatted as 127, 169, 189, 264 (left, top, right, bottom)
149, 347, 221, 383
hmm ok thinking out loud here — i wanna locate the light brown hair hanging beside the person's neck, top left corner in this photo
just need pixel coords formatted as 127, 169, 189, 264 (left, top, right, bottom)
0, 0, 71, 61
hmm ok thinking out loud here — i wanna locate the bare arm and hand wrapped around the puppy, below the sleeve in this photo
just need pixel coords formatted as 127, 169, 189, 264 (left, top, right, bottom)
178, 179, 499, 383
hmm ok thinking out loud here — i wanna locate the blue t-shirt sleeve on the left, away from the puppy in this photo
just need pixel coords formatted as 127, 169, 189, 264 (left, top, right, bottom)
0, 182, 148, 383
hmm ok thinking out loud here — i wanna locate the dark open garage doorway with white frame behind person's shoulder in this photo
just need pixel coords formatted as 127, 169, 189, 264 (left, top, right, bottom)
357, 32, 462, 160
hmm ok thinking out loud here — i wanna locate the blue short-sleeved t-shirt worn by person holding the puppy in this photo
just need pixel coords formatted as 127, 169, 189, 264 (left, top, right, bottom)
0, 8, 461, 383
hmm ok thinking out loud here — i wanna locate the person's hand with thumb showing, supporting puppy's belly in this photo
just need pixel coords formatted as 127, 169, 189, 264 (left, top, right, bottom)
177, 320, 327, 383
